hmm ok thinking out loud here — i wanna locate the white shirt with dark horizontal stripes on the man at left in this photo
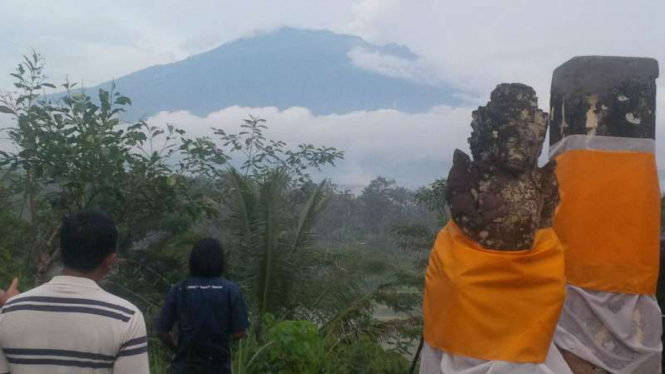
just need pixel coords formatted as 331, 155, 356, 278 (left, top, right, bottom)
0, 276, 150, 374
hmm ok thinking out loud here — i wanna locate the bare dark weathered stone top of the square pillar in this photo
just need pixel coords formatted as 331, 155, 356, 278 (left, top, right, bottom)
550, 56, 658, 144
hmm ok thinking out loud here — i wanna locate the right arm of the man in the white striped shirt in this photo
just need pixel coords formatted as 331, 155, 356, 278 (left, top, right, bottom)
113, 311, 150, 374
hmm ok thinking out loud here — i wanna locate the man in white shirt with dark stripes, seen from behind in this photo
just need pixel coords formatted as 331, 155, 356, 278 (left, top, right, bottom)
0, 211, 150, 374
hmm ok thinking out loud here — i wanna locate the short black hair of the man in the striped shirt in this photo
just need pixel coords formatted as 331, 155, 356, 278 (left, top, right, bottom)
60, 210, 118, 272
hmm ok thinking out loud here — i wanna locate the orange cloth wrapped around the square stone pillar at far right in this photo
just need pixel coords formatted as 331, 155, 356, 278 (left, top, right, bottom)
554, 150, 660, 295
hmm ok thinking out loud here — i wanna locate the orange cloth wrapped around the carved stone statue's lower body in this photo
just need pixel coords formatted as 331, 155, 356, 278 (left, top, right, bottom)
423, 221, 566, 363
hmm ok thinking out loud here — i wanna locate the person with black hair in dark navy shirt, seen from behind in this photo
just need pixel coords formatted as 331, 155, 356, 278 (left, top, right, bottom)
155, 238, 249, 374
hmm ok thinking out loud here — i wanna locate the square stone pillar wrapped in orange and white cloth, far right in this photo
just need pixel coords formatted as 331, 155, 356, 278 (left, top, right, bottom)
550, 56, 660, 374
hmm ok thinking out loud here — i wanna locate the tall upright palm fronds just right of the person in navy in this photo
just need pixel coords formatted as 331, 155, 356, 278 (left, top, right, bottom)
226, 169, 327, 338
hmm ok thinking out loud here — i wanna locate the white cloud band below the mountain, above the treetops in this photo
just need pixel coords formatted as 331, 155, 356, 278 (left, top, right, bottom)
148, 106, 471, 187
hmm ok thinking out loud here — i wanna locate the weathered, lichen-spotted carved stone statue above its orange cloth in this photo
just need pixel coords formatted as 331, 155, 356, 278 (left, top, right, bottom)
447, 83, 559, 250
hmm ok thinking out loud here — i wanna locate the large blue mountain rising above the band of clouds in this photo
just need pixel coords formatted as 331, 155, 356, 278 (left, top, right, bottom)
85, 28, 459, 118
